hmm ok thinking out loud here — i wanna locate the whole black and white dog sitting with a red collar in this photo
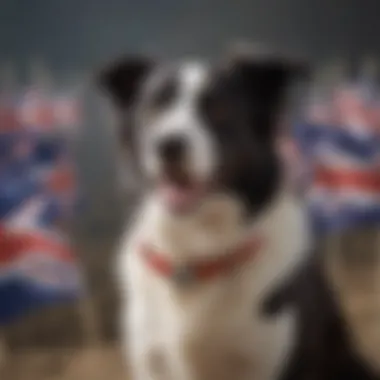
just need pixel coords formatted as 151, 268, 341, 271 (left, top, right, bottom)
97, 47, 378, 380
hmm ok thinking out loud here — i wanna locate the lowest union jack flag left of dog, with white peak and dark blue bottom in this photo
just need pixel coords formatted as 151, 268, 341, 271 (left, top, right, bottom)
0, 195, 83, 324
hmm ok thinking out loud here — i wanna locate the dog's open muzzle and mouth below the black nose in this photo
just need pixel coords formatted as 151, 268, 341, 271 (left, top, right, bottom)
157, 169, 210, 213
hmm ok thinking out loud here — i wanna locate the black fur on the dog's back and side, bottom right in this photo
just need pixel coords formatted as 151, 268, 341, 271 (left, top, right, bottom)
263, 252, 379, 380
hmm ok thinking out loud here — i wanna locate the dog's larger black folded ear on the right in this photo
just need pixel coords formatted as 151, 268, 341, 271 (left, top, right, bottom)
228, 46, 309, 142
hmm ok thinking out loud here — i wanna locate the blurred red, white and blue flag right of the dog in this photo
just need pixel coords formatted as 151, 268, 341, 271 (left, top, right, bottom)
296, 73, 380, 233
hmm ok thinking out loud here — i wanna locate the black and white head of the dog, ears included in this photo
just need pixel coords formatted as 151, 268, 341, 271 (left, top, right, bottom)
100, 49, 303, 218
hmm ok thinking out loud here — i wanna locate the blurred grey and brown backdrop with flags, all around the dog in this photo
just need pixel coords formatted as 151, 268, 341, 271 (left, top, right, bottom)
0, 0, 380, 380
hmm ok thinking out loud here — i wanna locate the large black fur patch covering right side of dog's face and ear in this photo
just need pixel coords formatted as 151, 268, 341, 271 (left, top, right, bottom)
199, 58, 300, 216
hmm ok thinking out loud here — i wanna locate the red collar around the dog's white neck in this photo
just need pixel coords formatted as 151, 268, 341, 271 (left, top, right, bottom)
141, 236, 263, 285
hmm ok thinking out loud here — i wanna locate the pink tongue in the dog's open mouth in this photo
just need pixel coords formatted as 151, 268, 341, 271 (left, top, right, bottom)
161, 184, 200, 211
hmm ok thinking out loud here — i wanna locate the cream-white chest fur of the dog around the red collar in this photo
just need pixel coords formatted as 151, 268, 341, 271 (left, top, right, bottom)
118, 196, 307, 380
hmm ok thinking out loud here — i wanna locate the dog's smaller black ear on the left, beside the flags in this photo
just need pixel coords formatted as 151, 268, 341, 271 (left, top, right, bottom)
96, 56, 154, 109
